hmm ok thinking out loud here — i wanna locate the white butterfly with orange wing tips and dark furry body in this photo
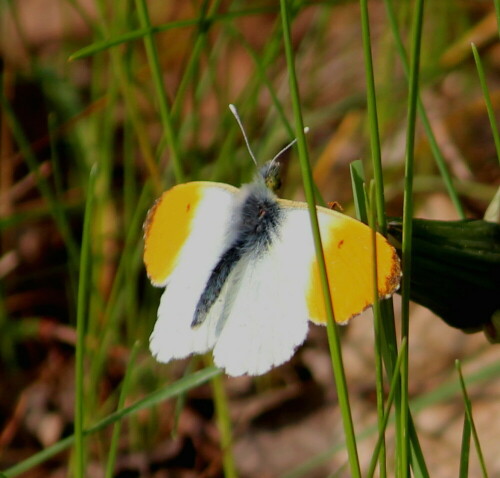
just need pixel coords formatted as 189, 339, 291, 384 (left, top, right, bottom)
144, 105, 401, 376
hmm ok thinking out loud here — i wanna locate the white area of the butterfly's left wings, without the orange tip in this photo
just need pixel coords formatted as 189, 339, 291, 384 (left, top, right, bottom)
150, 185, 238, 362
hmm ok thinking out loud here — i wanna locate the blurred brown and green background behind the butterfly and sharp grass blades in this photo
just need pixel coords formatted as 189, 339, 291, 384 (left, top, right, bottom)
0, 0, 500, 478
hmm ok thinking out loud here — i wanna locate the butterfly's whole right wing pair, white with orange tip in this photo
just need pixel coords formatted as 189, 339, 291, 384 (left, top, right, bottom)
214, 200, 401, 375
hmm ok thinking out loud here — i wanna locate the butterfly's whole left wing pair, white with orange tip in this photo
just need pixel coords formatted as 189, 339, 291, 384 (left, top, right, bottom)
144, 181, 238, 362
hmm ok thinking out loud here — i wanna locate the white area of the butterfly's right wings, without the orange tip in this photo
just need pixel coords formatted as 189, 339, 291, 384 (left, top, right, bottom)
214, 210, 314, 376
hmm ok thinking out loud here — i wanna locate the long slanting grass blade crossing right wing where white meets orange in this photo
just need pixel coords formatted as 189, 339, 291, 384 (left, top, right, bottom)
281, 0, 361, 477
